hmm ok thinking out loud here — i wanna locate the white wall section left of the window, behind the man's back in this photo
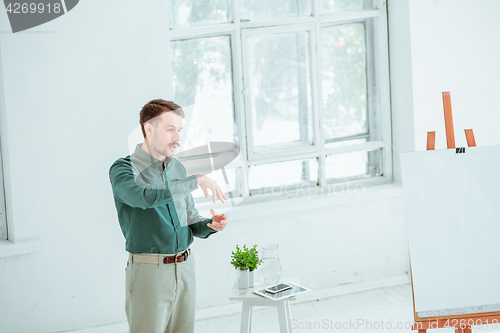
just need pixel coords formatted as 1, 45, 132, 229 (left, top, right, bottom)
0, 0, 176, 333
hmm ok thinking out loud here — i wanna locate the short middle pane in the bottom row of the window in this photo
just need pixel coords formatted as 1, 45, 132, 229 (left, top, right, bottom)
248, 158, 318, 194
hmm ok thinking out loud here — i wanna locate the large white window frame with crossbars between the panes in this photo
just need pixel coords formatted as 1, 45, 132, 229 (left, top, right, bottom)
166, 0, 393, 203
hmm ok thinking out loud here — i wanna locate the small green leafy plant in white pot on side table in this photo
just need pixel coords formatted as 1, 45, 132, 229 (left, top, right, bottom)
231, 244, 262, 293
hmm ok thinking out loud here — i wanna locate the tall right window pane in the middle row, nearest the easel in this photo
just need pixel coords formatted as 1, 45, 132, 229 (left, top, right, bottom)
321, 23, 368, 139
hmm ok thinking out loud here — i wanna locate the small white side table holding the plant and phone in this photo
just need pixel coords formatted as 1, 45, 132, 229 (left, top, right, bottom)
229, 277, 300, 333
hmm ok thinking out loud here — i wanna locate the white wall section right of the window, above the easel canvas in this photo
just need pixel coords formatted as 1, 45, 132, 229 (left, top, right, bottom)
409, 0, 500, 150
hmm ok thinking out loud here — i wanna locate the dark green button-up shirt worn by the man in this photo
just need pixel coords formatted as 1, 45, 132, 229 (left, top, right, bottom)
109, 144, 217, 254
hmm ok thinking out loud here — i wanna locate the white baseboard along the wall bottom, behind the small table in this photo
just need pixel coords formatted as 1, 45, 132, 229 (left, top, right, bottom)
59, 274, 410, 333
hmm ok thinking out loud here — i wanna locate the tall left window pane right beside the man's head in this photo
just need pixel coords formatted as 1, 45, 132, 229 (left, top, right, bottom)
172, 36, 238, 150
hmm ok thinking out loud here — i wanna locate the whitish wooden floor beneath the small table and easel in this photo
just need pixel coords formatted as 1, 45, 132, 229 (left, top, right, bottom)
195, 284, 500, 333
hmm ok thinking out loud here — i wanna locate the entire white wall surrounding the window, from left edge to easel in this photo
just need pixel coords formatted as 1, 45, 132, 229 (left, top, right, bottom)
0, 0, 500, 333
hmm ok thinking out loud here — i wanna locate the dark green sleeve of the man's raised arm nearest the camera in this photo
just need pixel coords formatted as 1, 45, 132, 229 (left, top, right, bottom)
109, 159, 198, 209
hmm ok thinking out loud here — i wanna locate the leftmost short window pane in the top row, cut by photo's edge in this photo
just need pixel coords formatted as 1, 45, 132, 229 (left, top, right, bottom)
170, 0, 231, 29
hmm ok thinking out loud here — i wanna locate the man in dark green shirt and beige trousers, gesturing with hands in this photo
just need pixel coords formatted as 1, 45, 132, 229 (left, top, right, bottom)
109, 99, 227, 333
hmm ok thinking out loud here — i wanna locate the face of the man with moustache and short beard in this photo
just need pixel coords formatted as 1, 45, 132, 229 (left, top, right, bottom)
150, 111, 182, 157
